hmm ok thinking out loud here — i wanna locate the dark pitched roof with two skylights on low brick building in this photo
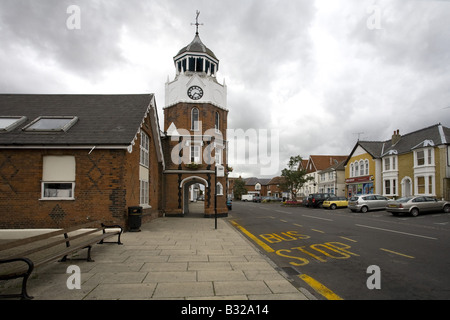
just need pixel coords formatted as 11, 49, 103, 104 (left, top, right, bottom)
0, 94, 159, 146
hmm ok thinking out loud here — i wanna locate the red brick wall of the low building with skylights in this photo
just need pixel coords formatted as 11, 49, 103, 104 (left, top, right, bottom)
0, 114, 161, 229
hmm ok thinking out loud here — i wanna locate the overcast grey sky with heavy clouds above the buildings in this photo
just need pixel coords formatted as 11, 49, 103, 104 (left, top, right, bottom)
0, 0, 450, 177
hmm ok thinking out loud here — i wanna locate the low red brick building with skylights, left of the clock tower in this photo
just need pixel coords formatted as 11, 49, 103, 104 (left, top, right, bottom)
0, 94, 163, 228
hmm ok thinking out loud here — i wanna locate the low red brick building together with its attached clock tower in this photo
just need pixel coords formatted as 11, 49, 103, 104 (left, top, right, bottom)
0, 20, 228, 228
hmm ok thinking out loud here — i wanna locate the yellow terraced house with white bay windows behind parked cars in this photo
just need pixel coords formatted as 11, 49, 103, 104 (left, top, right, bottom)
345, 124, 450, 199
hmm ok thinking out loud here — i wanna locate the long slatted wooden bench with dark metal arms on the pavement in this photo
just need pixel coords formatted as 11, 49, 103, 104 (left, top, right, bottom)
0, 221, 123, 299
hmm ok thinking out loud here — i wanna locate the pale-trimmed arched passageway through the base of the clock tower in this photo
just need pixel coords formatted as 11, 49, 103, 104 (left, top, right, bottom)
180, 176, 208, 217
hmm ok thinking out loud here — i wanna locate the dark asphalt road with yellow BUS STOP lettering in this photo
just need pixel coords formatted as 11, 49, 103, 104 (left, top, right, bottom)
229, 201, 450, 300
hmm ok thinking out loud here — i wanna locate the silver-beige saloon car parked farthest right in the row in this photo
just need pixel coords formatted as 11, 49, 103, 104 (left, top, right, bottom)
386, 196, 450, 217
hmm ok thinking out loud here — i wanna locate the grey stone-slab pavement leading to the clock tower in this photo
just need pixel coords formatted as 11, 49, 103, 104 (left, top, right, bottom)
0, 202, 314, 300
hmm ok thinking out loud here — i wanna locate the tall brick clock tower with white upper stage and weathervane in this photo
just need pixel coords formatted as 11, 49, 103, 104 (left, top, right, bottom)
163, 11, 228, 217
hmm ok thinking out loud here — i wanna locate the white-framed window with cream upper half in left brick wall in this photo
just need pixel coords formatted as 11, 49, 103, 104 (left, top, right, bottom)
41, 156, 75, 200
